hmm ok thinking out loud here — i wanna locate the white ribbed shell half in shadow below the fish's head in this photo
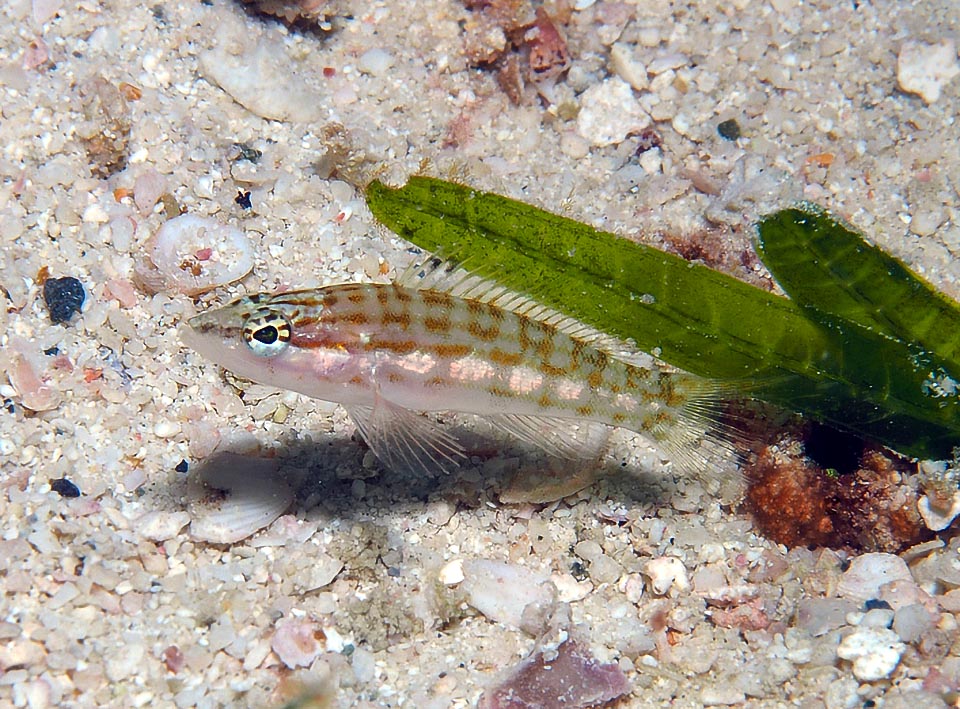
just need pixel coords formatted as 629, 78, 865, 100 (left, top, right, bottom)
187, 453, 293, 544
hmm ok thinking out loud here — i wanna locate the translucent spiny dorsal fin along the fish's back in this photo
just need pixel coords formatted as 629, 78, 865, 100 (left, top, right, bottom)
397, 254, 664, 368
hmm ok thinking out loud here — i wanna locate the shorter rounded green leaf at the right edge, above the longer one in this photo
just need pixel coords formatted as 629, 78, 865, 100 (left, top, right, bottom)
757, 207, 960, 365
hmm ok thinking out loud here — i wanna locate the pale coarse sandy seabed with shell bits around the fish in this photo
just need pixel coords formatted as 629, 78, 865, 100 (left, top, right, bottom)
0, 0, 960, 709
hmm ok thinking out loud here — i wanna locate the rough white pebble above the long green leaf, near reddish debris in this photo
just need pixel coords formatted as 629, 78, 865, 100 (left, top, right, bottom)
577, 76, 650, 147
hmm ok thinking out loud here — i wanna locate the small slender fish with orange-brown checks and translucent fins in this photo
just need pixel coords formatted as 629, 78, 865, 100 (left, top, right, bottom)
182, 256, 726, 473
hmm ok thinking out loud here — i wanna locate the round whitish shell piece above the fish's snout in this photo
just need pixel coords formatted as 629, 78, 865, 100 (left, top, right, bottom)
138, 214, 253, 295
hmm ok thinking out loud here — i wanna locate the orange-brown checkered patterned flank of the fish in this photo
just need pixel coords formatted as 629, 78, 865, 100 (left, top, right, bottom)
263, 284, 688, 432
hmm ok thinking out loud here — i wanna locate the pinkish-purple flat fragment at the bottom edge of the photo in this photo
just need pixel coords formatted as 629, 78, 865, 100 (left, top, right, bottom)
479, 640, 630, 709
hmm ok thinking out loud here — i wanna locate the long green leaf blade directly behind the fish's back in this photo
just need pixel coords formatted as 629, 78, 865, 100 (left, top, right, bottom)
367, 177, 960, 456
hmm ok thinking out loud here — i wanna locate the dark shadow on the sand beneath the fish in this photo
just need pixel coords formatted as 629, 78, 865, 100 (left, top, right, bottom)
189, 420, 696, 518
